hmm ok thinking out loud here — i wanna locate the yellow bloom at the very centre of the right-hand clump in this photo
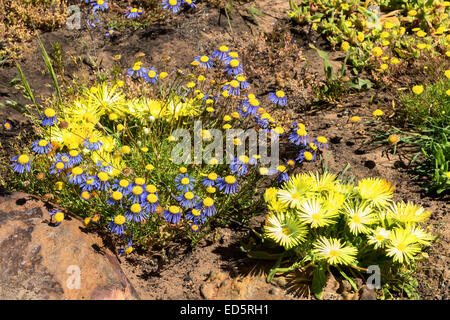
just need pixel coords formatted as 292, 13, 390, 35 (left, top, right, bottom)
344, 204, 378, 235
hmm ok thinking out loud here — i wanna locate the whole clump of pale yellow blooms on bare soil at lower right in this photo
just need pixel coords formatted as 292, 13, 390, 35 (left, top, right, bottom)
264, 172, 434, 296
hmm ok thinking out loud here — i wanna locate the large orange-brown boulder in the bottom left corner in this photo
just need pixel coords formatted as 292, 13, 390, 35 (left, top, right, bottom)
0, 192, 138, 300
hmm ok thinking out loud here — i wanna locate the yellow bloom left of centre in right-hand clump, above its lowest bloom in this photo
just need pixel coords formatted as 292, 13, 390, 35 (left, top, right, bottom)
297, 198, 338, 228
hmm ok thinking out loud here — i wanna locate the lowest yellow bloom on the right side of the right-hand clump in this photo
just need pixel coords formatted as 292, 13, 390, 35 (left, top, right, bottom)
386, 228, 420, 263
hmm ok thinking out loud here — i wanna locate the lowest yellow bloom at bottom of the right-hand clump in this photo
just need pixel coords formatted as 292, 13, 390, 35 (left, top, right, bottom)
313, 236, 358, 265
